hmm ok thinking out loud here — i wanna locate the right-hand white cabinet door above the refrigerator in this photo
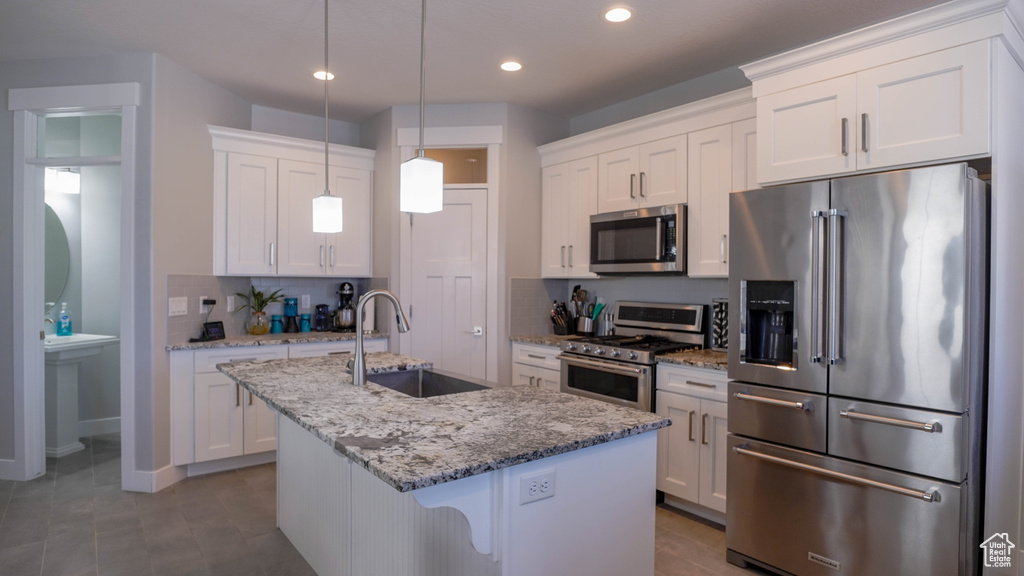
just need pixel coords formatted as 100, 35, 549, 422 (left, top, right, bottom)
856, 40, 989, 170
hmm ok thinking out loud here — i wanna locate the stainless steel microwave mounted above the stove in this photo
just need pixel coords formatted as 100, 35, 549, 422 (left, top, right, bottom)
590, 204, 686, 275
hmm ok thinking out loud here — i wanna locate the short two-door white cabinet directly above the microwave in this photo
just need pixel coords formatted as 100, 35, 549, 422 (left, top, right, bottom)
597, 134, 686, 213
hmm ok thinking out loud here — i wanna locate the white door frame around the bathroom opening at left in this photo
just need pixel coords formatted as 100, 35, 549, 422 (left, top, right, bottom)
6, 82, 140, 491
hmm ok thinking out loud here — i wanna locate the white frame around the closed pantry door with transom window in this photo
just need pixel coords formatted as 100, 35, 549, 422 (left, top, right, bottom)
397, 126, 504, 382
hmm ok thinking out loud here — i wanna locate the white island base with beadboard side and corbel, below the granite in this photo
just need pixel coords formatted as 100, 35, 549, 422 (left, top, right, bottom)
278, 414, 657, 576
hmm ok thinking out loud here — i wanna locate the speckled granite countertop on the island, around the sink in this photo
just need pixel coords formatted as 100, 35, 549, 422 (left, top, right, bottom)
217, 353, 671, 492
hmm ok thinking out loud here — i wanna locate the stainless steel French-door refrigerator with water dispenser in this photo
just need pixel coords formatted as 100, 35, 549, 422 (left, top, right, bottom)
726, 164, 988, 576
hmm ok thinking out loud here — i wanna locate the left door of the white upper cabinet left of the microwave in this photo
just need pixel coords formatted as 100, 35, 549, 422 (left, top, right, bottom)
541, 162, 571, 278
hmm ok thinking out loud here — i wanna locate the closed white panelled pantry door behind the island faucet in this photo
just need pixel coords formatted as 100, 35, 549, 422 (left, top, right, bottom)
409, 190, 487, 378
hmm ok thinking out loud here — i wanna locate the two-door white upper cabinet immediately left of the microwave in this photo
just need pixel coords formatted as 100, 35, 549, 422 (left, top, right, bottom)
541, 156, 597, 278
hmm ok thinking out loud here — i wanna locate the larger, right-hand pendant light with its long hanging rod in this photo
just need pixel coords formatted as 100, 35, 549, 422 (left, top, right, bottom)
398, 0, 444, 213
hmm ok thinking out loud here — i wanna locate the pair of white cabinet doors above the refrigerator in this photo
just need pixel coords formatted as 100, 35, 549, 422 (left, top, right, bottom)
757, 40, 990, 182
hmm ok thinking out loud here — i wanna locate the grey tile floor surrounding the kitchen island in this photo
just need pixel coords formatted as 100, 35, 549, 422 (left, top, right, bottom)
0, 435, 757, 576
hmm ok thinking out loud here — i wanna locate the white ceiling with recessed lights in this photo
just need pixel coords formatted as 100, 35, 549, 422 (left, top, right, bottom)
0, 0, 939, 122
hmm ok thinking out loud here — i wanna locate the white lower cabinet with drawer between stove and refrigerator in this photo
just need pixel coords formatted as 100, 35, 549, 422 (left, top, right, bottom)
655, 364, 728, 513
